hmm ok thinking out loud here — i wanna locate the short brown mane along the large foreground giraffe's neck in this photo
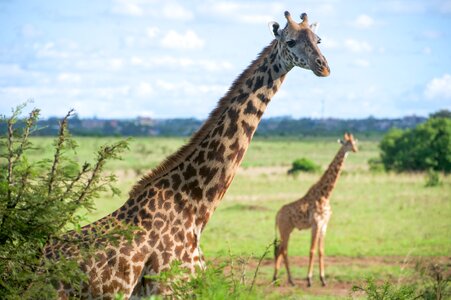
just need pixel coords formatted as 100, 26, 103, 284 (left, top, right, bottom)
129, 40, 277, 198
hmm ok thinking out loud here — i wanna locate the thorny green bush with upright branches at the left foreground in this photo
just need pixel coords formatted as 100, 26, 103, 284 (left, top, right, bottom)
0, 105, 128, 299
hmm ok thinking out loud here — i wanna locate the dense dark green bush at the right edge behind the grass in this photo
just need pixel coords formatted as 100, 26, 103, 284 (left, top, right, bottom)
380, 117, 451, 173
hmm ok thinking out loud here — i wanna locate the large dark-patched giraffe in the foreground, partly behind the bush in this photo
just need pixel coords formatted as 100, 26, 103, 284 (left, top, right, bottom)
47, 12, 330, 298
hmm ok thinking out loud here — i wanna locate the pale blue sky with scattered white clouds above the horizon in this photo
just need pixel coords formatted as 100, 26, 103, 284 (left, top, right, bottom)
0, 0, 451, 118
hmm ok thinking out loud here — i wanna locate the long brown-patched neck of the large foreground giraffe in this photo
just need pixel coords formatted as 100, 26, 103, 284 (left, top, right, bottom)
125, 40, 290, 229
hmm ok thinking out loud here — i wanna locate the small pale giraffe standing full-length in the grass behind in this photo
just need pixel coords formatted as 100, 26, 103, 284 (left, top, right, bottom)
273, 133, 358, 287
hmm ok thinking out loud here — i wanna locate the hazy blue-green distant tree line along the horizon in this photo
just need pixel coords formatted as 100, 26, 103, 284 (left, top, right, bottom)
0, 116, 426, 137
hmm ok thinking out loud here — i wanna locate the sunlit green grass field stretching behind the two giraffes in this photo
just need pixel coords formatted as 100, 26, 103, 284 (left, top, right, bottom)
32, 137, 451, 299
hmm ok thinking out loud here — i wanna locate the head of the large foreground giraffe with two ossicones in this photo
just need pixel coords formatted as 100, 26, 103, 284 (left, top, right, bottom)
269, 11, 330, 77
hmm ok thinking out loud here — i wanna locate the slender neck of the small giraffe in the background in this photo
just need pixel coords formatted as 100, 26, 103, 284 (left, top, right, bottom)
311, 147, 348, 199
